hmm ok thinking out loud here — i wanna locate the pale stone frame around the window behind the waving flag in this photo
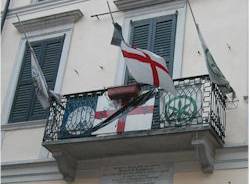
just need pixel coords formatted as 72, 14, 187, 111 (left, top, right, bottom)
114, 1, 186, 85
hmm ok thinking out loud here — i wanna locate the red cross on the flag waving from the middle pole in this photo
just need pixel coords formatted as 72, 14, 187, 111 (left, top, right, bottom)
122, 50, 168, 87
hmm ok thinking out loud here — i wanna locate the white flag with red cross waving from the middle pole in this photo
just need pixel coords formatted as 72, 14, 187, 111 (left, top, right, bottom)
121, 42, 176, 94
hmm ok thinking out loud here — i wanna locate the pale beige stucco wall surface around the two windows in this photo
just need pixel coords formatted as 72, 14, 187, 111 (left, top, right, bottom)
1, 0, 248, 165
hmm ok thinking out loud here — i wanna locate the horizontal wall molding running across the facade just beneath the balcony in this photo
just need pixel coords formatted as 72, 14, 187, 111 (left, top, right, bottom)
1, 145, 248, 184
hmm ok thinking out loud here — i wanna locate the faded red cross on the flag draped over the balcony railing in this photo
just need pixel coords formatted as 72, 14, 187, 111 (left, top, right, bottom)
95, 105, 154, 134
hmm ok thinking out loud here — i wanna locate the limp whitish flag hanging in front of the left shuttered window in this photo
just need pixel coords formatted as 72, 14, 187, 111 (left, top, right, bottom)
30, 48, 50, 109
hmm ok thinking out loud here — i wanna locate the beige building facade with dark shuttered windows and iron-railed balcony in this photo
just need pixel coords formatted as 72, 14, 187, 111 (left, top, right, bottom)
1, 0, 248, 184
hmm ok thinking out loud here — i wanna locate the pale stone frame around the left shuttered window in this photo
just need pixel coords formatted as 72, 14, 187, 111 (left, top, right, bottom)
2, 23, 74, 126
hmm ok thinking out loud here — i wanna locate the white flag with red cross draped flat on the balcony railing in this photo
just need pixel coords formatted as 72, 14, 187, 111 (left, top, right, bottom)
92, 96, 155, 136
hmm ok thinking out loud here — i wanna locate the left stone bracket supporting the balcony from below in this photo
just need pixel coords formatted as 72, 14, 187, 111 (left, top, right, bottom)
53, 152, 77, 182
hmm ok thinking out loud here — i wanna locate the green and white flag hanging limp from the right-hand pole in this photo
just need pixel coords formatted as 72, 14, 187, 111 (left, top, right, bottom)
196, 24, 236, 98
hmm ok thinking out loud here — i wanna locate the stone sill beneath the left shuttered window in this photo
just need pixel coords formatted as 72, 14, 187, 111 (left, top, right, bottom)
1, 119, 47, 131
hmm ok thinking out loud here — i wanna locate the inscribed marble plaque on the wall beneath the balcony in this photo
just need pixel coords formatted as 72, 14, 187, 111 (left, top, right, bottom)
101, 163, 173, 184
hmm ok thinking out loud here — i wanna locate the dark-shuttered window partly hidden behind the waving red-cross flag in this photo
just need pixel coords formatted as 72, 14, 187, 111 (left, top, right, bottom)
127, 14, 177, 83
